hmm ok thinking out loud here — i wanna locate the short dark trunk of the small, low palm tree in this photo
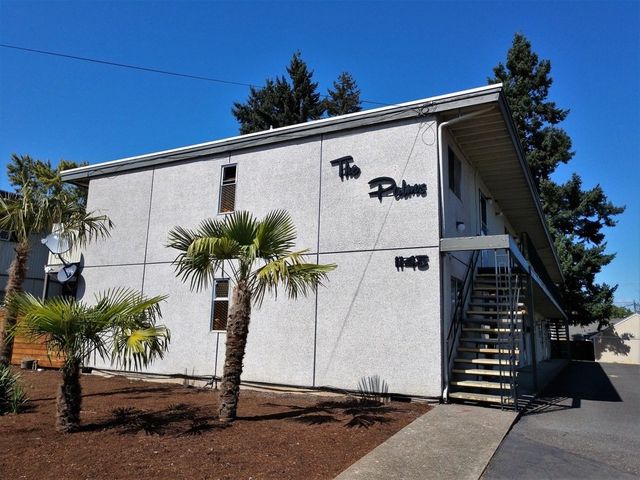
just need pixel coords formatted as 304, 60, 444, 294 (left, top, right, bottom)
56, 358, 82, 432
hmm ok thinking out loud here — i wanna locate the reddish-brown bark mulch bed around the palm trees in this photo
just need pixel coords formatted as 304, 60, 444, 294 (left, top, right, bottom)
0, 371, 429, 480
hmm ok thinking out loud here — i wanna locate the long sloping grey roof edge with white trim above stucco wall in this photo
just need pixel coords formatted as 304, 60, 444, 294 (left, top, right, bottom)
62, 84, 502, 186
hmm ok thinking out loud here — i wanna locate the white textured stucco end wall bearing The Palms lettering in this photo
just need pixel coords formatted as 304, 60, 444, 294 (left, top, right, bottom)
79, 118, 441, 397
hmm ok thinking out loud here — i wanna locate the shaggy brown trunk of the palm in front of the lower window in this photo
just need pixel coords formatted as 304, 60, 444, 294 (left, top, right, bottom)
218, 282, 251, 422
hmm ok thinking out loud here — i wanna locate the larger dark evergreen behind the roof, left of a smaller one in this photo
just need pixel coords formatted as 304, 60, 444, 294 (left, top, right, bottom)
231, 52, 324, 135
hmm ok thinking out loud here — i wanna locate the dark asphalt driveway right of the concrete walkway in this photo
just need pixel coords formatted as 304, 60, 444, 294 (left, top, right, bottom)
482, 362, 640, 480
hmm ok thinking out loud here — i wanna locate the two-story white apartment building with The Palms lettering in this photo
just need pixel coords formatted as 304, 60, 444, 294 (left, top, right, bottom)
63, 85, 566, 403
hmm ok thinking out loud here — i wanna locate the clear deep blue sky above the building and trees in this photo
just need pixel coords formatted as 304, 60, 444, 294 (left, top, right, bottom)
0, 0, 640, 302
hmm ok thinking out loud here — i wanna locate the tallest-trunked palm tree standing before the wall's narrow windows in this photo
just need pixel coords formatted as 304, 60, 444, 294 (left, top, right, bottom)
168, 210, 336, 422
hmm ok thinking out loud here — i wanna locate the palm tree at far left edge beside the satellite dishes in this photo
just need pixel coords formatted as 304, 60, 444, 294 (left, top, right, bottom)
0, 154, 113, 365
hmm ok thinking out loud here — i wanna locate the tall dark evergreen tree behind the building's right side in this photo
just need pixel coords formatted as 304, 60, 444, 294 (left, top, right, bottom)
489, 33, 624, 324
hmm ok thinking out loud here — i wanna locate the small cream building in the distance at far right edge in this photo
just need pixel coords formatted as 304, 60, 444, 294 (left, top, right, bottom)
591, 313, 640, 365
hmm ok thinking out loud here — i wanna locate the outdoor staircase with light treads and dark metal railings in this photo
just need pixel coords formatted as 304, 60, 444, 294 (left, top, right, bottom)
448, 257, 526, 408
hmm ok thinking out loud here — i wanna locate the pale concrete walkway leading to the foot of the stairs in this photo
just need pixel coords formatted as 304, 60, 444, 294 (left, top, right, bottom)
336, 405, 517, 480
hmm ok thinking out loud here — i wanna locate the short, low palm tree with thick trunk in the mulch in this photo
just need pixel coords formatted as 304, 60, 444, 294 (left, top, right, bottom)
9, 289, 170, 432
